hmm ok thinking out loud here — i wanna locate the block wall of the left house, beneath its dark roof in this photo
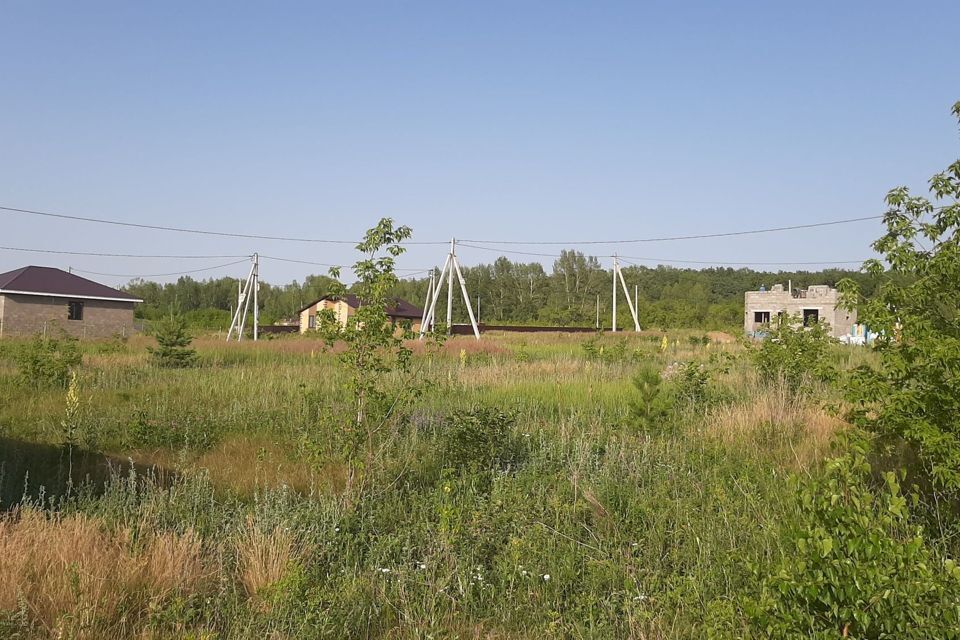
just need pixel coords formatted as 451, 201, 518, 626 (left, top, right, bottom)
0, 293, 134, 338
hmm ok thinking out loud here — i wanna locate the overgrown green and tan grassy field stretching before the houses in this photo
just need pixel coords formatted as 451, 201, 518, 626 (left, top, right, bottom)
0, 333, 852, 638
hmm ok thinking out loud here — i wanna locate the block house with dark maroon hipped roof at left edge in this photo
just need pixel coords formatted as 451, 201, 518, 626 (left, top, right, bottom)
0, 266, 143, 338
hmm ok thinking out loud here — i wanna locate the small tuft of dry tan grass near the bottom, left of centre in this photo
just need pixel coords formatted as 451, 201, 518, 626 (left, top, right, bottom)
236, 522, 299, 597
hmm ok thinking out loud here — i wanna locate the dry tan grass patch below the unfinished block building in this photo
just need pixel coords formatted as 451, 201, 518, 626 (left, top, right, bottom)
705, 385, 846, 469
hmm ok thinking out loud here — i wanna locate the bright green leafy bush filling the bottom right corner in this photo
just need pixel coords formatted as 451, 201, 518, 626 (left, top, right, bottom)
747, 445, 960, 640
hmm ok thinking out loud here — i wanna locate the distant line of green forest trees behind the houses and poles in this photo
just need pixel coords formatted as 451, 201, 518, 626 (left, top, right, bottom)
124, 251, 874, 330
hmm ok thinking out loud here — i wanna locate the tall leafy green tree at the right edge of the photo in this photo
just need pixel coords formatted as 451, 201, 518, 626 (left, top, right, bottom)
841, 102, 960, 496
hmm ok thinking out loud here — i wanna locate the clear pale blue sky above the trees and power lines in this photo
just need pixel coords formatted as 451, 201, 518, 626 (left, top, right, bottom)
0, 0, 960, 284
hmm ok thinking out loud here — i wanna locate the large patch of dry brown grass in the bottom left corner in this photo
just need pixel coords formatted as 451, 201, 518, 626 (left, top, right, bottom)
0, 510, 210, 640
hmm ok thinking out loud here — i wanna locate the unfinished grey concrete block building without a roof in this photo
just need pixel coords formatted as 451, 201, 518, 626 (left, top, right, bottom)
743, 284, 857, 338
